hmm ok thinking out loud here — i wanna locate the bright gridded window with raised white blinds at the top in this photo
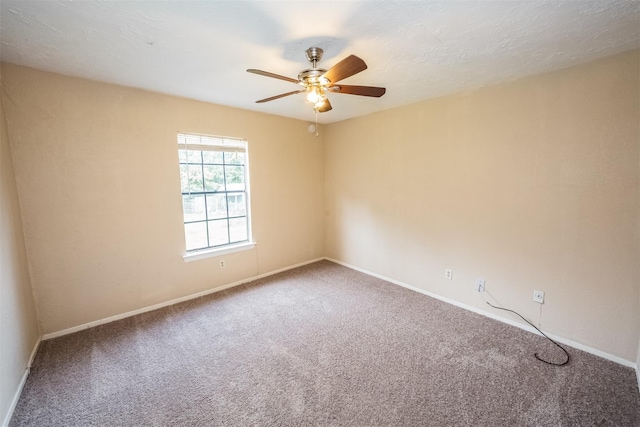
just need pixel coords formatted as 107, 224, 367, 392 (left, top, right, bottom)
178, 133, 251, 260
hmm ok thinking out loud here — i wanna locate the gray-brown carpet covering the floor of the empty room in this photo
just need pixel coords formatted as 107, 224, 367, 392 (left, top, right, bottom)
10, 261, 640, 426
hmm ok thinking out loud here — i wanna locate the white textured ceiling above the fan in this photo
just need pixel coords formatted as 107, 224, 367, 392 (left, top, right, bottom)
0, 0, 640, 123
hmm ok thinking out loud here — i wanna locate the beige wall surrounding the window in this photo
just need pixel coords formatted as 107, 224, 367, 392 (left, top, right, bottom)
2, 64, 323, 334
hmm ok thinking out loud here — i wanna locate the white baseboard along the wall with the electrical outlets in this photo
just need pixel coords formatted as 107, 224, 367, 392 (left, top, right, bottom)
325, 257, 640, 372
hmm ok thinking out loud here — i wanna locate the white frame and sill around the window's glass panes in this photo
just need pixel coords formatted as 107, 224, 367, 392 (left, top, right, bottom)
177, 132, 255, 262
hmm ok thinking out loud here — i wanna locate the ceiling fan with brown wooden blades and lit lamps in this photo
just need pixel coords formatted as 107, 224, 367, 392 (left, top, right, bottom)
247, 47, 386, 113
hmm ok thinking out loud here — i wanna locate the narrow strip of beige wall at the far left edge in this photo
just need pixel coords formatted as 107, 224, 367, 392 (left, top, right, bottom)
0, 67, 40, 425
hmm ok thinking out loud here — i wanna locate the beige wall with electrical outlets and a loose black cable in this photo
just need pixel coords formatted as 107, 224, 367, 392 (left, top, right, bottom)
325, 51, 640, 362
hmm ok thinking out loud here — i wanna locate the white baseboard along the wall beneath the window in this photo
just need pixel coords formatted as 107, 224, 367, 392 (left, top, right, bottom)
42, 258, 324, 340
